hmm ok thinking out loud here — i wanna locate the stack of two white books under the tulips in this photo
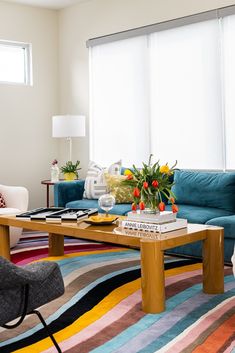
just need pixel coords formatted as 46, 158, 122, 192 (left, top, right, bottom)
119, 211, 187, 233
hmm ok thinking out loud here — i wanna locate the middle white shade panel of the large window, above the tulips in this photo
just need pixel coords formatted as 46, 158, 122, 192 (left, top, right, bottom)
150, 20, 223, 169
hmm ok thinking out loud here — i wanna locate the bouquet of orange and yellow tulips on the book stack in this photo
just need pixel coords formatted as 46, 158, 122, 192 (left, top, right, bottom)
123, 154, 178, 213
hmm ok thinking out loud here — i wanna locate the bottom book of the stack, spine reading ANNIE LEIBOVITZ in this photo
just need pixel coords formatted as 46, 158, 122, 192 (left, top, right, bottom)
119, 218, 187, 233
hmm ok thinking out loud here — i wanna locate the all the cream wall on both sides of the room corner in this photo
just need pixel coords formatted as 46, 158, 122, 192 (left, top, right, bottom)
0, 0, 235, 208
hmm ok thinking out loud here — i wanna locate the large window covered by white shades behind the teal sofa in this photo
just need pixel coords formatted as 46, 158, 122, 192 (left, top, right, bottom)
90, 10, 235, 170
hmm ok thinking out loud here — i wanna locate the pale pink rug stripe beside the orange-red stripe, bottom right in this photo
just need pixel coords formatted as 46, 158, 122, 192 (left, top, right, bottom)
163, 298, 235, 353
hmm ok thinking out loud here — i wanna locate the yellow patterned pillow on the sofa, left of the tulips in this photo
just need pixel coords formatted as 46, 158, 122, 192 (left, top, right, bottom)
105, 173, 133, 203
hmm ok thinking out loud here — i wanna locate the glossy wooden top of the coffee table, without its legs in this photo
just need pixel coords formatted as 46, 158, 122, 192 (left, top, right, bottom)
0, 215, 223, 250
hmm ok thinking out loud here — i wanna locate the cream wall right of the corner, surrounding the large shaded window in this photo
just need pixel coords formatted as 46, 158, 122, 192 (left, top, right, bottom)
59, 0, 235, 175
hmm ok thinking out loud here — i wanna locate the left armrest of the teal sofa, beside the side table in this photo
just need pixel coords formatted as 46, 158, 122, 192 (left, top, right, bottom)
54, 179, 85, 207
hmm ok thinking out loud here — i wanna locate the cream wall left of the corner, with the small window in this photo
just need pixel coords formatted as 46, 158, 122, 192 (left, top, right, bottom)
0, 1, 58, 208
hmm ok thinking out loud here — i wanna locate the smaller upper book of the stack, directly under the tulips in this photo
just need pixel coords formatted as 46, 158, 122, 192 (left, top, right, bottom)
127, 210, 176, 224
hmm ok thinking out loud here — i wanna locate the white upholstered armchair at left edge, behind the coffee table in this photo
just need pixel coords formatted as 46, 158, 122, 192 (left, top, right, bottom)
0, 185, 29, 248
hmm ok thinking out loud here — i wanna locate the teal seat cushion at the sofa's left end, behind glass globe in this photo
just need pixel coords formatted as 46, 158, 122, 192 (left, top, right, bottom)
66, 199, 131, 215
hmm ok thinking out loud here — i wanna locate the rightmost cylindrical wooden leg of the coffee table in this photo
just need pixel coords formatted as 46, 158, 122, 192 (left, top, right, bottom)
203, 228, 224, 294
